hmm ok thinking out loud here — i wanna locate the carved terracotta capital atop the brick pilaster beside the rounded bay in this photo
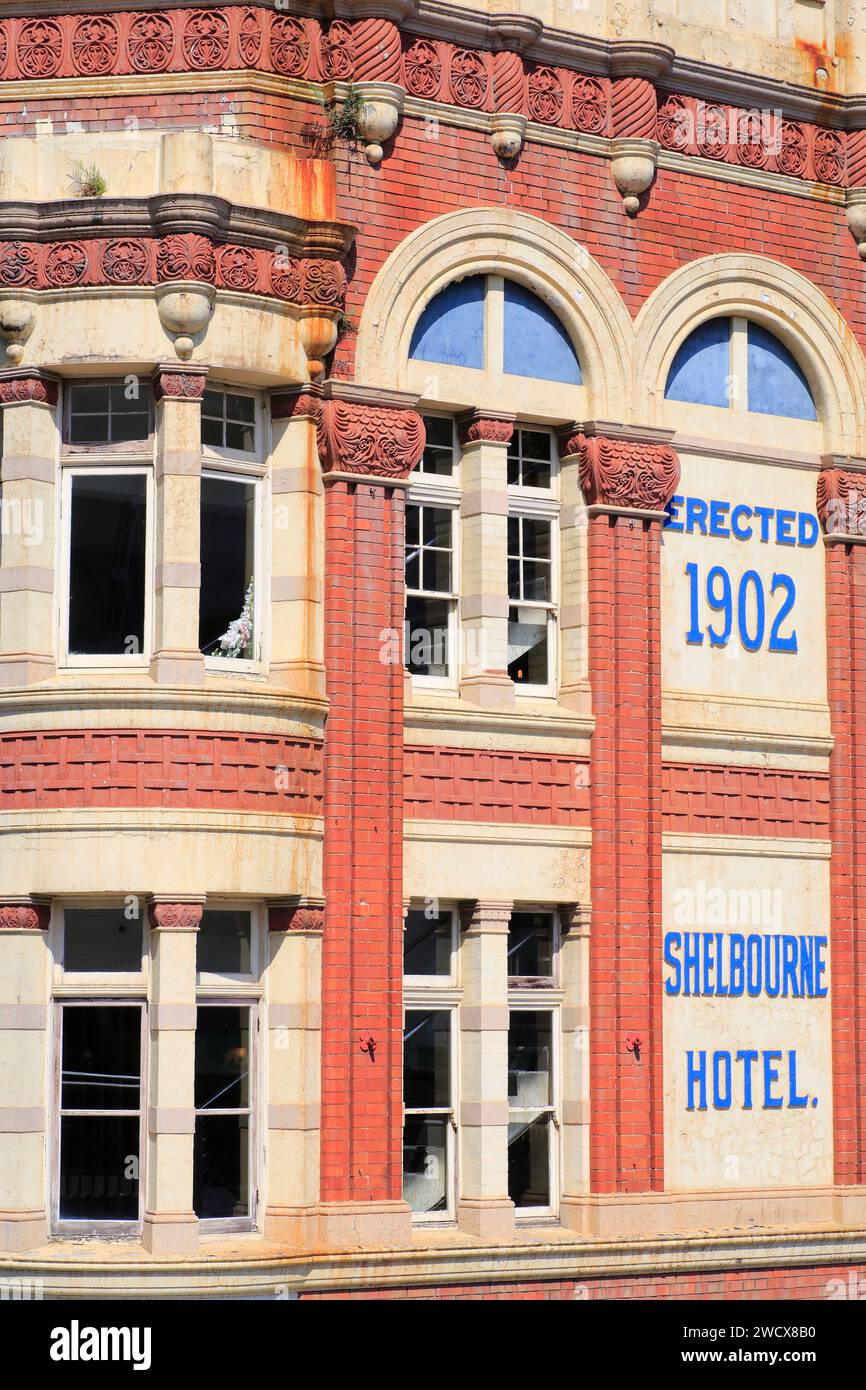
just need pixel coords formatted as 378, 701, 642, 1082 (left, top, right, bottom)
316, 378, 424, 482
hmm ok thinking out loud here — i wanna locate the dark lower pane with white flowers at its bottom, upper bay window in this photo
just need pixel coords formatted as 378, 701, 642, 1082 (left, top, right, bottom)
199, 474, 256, 659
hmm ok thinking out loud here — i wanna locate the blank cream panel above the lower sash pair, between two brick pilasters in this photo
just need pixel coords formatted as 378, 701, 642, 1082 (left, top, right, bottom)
403, 820, 589, 904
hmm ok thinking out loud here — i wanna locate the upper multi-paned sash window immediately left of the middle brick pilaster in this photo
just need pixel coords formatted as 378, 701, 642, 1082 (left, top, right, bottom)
507, 428, 559, 695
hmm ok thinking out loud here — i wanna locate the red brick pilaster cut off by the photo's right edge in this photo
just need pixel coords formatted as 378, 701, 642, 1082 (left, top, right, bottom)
817, 460, 866, 1186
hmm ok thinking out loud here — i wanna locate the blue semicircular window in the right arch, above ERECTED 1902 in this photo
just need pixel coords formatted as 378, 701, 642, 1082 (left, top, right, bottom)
664, 318, 817, 420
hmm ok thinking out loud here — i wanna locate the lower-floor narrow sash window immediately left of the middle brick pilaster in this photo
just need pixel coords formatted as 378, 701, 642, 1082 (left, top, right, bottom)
507, 912, 560, 1215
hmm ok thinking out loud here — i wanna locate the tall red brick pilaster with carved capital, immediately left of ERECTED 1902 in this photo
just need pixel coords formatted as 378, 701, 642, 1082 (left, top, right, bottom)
564, 425, 680, 1193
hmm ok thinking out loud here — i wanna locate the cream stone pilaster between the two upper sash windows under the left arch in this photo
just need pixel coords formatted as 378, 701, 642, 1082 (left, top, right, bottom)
460, 411, 514, 709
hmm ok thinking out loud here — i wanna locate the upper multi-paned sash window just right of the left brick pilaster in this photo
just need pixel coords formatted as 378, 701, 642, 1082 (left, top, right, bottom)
403, 416, 460, 684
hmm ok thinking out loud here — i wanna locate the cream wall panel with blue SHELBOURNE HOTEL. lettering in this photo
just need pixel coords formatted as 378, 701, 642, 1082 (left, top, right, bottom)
659, 842, 833, 1191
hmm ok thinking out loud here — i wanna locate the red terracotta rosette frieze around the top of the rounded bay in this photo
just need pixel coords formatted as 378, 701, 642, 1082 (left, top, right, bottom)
0, 234, 346, 311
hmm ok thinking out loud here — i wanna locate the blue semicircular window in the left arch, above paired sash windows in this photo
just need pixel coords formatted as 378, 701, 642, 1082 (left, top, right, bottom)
409, 275, 582, 386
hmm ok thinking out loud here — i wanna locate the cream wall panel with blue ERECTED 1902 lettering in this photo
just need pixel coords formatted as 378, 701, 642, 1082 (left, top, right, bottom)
662, 453, 827, 717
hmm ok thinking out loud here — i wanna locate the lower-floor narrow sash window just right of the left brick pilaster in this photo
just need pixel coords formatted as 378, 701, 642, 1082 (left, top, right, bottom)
403, 906, 457, 1220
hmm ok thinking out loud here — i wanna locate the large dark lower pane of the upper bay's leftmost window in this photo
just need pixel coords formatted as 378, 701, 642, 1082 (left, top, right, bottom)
70, 473, 147, 656
